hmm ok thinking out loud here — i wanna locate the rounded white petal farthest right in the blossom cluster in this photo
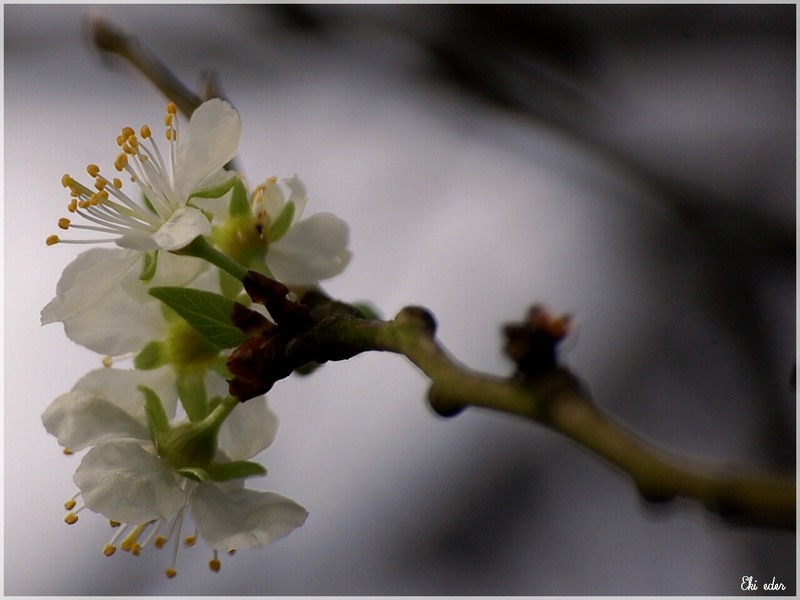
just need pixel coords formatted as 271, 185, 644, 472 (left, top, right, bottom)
267, 213, 351, 285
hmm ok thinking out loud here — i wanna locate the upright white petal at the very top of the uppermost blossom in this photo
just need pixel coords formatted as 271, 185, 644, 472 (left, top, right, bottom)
175, 98, 242, 202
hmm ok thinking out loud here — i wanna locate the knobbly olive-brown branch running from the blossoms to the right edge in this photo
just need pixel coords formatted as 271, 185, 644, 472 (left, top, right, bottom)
229, 278, 796, 529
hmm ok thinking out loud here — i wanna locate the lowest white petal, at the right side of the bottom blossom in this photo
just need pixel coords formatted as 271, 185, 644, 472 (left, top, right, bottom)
190, 484, 308, 551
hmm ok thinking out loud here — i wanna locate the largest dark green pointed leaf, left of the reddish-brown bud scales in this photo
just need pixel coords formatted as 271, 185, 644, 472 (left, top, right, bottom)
150, 287, 247, 350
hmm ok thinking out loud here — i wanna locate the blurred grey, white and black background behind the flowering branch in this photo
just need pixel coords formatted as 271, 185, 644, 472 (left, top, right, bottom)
4, 5, 796, 596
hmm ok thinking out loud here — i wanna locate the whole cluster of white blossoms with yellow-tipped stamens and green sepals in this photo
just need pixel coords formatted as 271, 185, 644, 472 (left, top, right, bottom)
41, 99, 350, 577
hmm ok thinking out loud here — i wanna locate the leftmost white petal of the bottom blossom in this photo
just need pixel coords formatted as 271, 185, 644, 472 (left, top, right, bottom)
42, 392, 149, 451
